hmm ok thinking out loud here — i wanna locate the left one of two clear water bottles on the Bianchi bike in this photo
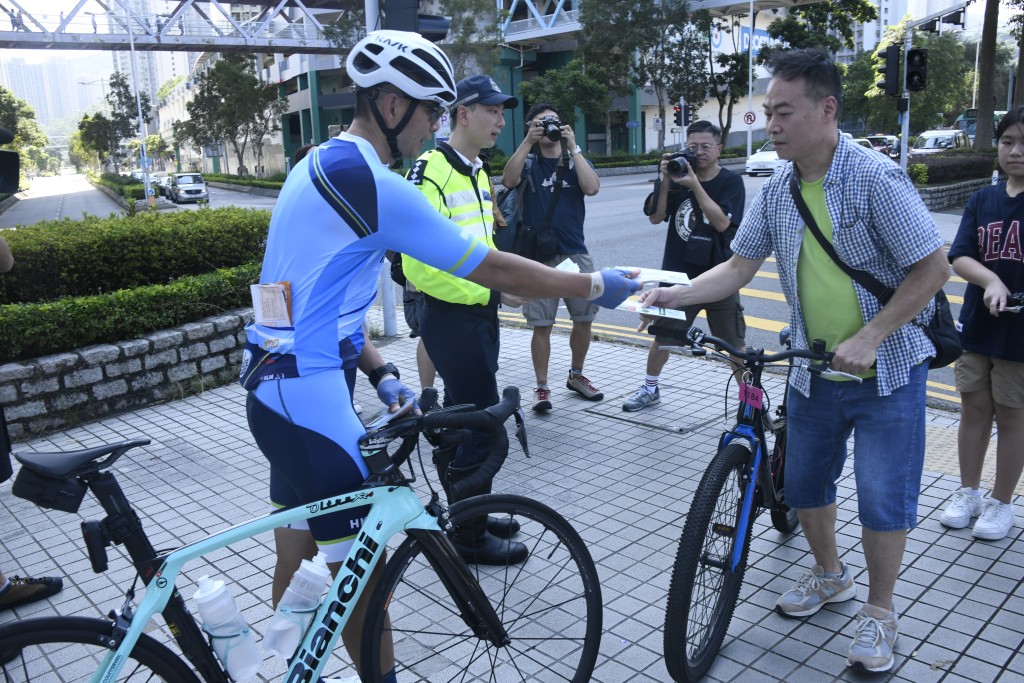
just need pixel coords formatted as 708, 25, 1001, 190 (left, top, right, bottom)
193, 575, 263, 681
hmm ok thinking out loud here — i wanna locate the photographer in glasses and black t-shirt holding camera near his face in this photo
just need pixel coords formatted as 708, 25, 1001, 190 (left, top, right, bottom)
623, 121, 746, 412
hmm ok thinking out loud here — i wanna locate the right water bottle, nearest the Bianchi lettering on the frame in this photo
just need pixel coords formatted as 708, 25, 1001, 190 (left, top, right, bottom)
263, 553, 331, 659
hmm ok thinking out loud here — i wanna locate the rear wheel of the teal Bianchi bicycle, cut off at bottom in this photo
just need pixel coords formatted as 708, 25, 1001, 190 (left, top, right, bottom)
0, 616, 200, 683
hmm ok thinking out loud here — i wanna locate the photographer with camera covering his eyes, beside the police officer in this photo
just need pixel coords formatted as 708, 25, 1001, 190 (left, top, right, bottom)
502, 102, 604, 412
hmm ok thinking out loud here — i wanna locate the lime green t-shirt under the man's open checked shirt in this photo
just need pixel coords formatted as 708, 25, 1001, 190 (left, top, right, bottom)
797, 177, 874, 379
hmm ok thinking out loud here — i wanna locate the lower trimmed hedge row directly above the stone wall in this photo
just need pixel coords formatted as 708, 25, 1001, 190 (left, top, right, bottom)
0, 262, 260, 360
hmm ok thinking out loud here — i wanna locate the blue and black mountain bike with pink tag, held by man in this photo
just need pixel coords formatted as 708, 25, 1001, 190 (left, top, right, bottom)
649, 326, 860, 683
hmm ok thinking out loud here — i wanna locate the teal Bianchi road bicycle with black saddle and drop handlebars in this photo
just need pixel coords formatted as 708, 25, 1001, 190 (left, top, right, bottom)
0, 387, 602, 683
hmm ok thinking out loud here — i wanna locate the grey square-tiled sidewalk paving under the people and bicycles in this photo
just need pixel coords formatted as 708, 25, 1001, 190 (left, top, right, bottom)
0, 316, 1024, 683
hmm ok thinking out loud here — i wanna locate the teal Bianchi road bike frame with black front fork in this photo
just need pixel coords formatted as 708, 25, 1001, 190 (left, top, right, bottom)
91, 485, 499, 683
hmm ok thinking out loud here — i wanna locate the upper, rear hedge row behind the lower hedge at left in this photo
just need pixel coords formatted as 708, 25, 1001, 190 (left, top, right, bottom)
0, 207, 270, 305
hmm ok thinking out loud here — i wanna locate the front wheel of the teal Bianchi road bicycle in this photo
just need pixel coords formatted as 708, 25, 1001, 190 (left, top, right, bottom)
360, 495, 602, 683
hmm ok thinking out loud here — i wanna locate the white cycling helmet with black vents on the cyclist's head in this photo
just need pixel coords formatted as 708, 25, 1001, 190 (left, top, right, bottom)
345, 31, 456, 106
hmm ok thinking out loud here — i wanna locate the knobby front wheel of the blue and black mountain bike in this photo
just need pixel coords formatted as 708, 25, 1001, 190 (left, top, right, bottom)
664, 442, 756, 683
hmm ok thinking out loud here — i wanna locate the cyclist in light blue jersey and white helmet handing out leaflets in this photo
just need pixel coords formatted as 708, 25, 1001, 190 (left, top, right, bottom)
241, 31, 640, 670
